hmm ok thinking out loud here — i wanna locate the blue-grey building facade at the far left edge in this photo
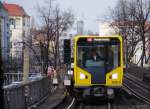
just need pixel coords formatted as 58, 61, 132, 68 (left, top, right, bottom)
0, 2, 9, 65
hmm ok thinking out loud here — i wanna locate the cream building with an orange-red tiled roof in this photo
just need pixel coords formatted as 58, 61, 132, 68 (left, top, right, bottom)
4, 3, 30, 59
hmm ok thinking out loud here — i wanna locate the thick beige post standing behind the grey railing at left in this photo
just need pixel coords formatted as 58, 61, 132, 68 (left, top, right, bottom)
23, 46, 29, 83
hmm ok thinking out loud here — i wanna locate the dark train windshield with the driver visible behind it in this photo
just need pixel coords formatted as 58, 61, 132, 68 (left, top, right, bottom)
77, 38, 120, 73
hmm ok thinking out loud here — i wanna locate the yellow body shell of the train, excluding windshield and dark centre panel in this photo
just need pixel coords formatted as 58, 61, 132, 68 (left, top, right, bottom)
73, 36, 123, 87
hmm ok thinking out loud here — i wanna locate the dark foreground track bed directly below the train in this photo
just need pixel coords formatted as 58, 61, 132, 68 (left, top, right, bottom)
55, 91, 150, 109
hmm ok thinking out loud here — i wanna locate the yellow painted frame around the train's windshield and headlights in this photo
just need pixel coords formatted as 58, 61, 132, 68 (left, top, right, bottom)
74, 35, 123, 86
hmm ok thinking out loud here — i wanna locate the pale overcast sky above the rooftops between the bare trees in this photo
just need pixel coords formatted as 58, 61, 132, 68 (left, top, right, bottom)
2, 0, 117, 32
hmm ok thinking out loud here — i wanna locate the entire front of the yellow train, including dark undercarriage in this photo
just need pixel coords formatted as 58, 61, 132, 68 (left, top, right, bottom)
73, 36, 123, 98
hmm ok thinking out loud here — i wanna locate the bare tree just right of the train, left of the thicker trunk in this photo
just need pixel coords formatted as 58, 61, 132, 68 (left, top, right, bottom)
111, 0, 137, 63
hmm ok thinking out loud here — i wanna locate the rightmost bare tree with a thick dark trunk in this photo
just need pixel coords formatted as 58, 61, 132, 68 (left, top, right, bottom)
134, 0, 150, 66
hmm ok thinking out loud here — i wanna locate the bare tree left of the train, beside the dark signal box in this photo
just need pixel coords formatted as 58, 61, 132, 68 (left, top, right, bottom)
34, 0, 74, 73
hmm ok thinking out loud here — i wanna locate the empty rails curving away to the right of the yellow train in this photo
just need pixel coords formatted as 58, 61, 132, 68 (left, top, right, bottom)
123, 76, 150, 104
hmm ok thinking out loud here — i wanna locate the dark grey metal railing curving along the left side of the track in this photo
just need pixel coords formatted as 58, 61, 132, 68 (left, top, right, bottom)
3, 77, 52, 109
